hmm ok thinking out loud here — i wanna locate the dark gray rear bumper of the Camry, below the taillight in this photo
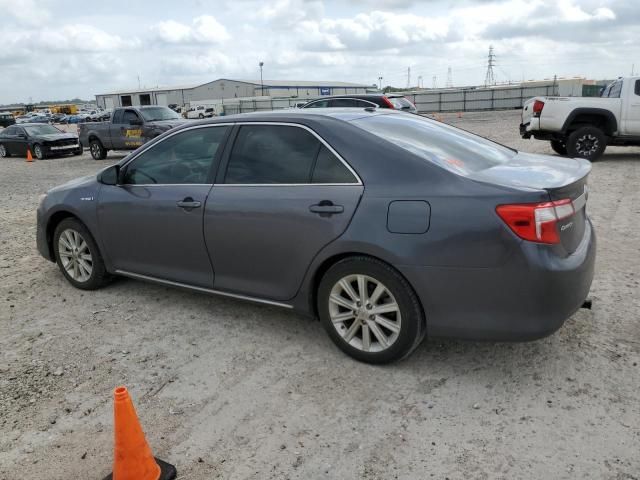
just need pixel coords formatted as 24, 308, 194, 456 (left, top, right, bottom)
399, 222, 596, 341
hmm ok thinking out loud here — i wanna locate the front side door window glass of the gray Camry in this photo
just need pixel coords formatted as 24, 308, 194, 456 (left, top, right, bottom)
124, 126, 228, 185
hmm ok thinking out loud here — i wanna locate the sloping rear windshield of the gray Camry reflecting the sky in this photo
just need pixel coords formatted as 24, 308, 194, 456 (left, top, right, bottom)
351, 114, 517, 175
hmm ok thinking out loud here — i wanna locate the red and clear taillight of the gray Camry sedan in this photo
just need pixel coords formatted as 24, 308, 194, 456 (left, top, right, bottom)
496, 198, 575, 244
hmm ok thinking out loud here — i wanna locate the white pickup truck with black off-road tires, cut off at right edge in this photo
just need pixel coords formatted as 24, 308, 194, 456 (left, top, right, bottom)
520, 77, 640, 160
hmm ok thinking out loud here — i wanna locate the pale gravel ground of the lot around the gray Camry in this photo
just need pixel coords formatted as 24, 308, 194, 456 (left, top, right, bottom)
0, 112, 640, 480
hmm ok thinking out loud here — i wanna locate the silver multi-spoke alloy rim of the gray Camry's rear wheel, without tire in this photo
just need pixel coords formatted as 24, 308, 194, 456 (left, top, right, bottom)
329, 275, 402, 352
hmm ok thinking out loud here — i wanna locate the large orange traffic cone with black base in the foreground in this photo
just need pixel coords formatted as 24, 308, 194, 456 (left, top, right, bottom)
104, 387, 177, 480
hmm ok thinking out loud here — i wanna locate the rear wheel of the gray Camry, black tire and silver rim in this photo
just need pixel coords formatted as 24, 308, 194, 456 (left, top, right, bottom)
317, 257, 425, 364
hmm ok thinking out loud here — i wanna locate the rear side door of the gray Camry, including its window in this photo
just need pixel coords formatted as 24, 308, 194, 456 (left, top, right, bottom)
204, 123, 363, 300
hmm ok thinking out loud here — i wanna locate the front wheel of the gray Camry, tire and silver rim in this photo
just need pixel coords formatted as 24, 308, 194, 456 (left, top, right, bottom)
53, 218, 110, 290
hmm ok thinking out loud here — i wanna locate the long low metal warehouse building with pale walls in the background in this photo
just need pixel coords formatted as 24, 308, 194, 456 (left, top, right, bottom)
96, 78, 369, 109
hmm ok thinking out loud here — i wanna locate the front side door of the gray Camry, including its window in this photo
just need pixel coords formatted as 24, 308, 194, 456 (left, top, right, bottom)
98, 126, 228, 288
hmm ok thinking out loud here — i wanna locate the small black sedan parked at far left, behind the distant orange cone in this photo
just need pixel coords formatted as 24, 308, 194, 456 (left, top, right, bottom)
0, 123, 82, 159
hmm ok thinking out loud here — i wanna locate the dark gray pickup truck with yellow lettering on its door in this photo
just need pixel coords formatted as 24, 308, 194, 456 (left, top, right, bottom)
78, 105, 185, 160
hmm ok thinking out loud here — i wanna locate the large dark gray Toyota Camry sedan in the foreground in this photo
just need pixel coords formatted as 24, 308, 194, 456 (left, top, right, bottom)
37, 108, 595, 363
